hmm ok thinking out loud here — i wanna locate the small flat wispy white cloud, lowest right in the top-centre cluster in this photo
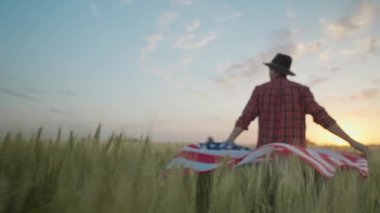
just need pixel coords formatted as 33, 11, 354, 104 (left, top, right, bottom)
173, 33, 216, 50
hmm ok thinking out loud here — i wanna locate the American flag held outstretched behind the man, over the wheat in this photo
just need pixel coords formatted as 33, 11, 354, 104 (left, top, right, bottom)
165, 141, 368, 177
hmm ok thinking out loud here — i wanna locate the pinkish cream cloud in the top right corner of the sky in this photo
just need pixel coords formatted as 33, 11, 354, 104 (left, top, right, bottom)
322, 0, 379, 38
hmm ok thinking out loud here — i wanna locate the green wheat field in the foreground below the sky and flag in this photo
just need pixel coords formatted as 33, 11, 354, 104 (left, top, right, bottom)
0, 129, 380, 213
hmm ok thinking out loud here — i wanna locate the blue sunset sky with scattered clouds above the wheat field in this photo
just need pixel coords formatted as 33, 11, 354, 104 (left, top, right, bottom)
0, 0, 380, 145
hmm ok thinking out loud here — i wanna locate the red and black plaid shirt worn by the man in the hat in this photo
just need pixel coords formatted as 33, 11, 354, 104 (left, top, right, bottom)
235, 77, 335, 147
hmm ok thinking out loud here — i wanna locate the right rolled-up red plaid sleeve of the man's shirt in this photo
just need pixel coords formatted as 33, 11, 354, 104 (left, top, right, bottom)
304, 87, 336, 129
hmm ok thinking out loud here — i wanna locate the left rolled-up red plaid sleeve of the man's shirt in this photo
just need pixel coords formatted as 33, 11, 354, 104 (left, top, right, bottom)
235, 87, 259, 130
